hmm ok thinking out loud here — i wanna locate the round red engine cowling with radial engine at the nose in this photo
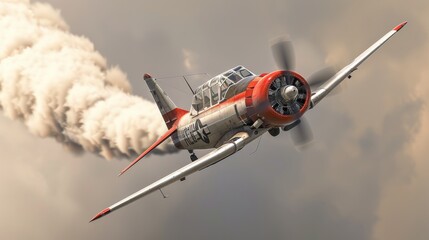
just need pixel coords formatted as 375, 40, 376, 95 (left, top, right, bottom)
245, 71, 311, 126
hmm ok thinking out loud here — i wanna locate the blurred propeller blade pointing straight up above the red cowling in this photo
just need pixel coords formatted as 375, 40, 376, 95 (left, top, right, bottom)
271, 38, 295, 70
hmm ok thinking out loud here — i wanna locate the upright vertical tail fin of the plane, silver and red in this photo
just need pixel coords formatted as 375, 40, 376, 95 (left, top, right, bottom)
143, 73, 188, 129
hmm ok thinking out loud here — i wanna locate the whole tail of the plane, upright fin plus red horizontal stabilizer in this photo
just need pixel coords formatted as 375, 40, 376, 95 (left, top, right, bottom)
119, 73, 188, 176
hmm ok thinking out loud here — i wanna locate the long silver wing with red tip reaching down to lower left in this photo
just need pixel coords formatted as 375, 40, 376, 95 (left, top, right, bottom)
90, 132, 249, 222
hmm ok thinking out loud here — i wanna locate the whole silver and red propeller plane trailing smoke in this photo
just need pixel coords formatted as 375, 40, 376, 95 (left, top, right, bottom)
91, 22, 407, 221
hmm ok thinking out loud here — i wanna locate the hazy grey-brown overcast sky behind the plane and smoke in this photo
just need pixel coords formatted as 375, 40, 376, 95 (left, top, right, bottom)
0, 0, 429, 240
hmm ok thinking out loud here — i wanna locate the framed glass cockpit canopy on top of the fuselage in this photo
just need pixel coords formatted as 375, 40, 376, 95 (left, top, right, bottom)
191, 66, 255, 115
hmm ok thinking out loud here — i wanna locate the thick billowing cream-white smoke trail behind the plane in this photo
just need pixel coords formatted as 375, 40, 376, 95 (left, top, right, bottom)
0, 0, 174, 159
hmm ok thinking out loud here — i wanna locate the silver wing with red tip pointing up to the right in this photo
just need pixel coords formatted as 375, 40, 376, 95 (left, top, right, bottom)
311, 22, 407, 108
